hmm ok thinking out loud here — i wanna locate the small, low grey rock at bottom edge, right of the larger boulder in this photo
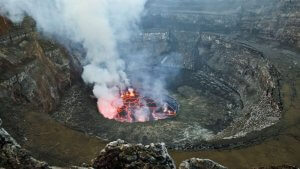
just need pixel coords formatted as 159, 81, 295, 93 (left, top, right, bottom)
179, 158, 227, 169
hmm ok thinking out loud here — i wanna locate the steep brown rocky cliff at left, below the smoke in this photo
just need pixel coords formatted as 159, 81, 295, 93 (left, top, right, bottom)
0, 19, 71, 112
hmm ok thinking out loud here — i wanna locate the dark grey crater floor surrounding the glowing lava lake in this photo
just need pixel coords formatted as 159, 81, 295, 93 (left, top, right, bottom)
51, 66, 262, 148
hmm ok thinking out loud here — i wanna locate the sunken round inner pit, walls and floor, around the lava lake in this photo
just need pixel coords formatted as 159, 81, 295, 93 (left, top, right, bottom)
51, 30, 281, 149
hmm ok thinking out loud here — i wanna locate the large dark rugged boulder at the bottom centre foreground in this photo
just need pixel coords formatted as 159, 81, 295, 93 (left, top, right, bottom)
93, 140, 176, 169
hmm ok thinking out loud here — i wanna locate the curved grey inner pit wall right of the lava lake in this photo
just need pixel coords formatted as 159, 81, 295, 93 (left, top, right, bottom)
197, 33, 282, 137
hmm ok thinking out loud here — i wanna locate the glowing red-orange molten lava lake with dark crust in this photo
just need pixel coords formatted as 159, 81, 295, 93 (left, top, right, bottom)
98, 88, 176, 122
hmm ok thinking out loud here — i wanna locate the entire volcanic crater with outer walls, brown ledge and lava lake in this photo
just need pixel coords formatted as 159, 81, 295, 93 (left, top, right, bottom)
0, 0, 300, 168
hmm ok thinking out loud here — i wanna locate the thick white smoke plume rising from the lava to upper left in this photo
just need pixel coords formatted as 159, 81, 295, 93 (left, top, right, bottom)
0, 0, 146, 118
